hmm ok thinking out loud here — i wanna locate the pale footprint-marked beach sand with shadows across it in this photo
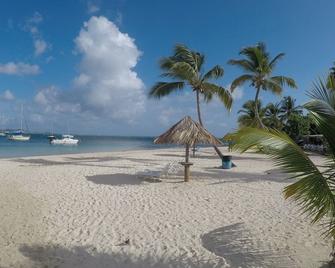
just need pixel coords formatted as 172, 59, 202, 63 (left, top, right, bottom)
0, 148, 331, 268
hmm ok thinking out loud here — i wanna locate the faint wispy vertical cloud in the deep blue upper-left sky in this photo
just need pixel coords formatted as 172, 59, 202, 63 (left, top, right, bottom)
24, 11, 51, 57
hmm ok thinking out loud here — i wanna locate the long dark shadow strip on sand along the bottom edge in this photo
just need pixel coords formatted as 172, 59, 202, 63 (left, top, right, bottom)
19, 245, 223, 268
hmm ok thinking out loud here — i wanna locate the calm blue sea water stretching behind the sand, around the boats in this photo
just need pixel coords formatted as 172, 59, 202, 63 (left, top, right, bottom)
0, 134, 164, 158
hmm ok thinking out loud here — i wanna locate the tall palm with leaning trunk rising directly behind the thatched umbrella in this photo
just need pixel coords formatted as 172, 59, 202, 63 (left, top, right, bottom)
149, 45, 232, 158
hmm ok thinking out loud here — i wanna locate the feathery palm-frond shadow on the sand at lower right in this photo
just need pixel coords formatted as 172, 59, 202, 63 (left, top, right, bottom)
201, 223, 297, 268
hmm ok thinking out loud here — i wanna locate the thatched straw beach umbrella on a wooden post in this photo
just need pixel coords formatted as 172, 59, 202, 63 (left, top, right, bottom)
154, 116, 222, 181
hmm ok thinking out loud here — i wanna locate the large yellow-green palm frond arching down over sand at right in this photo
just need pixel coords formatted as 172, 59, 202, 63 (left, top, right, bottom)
232, 128, 335, 234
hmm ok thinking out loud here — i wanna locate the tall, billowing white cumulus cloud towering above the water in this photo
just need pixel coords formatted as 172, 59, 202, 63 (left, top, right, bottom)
35, 17, 145, 122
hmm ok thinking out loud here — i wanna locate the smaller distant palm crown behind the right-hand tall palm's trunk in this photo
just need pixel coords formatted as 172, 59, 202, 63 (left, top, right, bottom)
237, 100, 265, 127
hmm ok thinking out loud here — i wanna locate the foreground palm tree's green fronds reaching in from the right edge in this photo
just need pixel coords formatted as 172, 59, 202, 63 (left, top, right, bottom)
231, 80, 335, 257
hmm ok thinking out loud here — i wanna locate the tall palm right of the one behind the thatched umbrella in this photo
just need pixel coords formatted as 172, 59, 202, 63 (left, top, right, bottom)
228, 43, 297, 128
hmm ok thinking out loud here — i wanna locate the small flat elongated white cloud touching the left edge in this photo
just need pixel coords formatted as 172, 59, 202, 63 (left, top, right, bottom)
0, 62, 40, 75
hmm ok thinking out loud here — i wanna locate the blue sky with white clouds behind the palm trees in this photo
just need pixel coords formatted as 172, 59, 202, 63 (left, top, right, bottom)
0, 0, 335, 136
